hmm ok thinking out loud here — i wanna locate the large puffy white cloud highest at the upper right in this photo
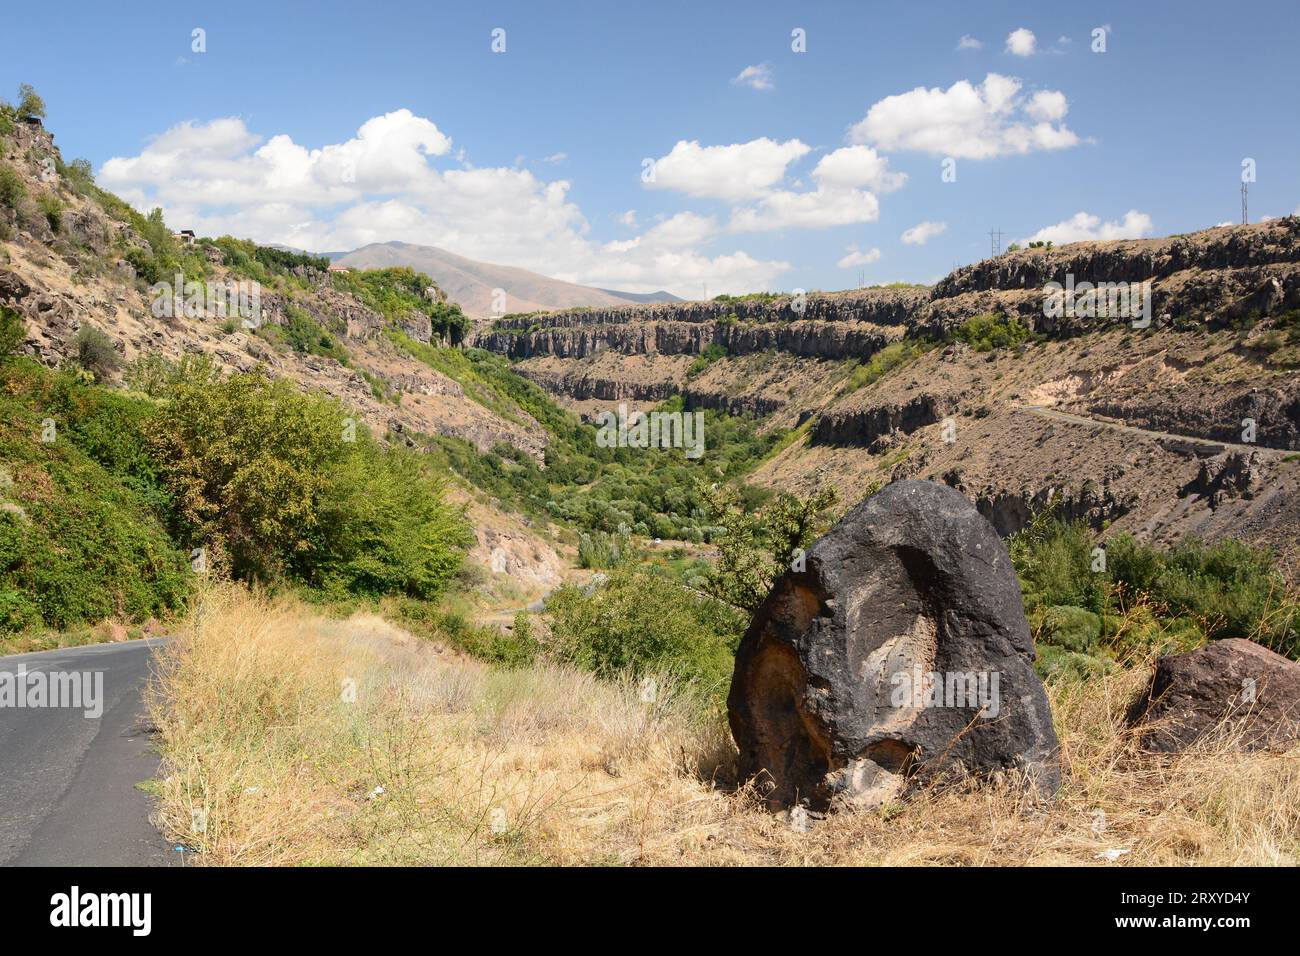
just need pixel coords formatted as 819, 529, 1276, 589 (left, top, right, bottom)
849, 73, 1079, 159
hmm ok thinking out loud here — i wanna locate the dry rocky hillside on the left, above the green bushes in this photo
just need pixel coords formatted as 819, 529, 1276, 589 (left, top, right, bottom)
0, 115, 546, 457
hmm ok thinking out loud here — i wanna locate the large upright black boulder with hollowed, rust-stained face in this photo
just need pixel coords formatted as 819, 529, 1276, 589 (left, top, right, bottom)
727, 481, 1060, 809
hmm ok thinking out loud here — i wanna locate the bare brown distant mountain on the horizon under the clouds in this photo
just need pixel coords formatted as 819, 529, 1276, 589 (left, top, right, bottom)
332, 242, 675, 319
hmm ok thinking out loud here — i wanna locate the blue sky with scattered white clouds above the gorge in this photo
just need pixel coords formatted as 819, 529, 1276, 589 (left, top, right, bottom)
0, 0, 1300, 297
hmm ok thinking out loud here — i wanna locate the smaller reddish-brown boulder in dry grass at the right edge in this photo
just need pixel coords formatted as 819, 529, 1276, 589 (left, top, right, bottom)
1128, 637, 1300, 753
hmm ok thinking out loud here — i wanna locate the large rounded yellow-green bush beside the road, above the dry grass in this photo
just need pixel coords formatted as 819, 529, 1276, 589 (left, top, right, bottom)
148, 360, 469, 598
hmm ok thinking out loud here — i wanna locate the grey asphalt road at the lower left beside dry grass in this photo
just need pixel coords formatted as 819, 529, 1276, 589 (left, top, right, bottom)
0, 639, 173, 866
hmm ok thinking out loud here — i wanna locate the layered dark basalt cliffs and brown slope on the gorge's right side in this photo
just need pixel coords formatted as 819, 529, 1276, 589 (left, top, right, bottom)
476, 217, 1300, 572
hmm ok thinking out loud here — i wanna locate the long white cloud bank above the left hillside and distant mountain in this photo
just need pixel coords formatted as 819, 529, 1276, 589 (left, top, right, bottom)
98, 109, 785, 293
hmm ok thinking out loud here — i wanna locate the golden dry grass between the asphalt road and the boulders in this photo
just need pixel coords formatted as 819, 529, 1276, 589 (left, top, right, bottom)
151, 588, 1300, 865
